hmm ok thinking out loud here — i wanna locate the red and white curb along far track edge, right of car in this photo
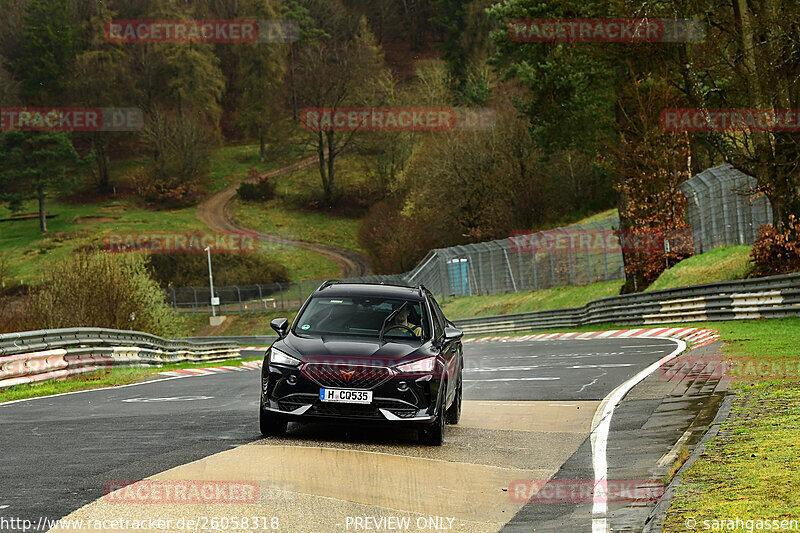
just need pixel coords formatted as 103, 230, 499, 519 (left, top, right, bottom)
462, 328, 719, 349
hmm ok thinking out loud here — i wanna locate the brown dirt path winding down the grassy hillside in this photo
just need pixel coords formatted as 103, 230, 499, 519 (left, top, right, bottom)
197, 155, 369, 278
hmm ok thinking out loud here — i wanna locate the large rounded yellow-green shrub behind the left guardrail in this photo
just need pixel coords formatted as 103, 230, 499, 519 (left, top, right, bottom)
26, 251, 180, 336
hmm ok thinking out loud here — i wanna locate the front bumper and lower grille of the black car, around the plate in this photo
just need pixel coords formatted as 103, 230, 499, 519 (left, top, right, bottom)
261, 365, 441, 425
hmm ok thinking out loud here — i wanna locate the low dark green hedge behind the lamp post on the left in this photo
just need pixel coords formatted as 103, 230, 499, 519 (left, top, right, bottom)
148, 254, 289, 287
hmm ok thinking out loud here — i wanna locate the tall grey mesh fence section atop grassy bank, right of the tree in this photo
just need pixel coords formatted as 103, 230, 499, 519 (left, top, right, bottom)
680, 163, 772, 254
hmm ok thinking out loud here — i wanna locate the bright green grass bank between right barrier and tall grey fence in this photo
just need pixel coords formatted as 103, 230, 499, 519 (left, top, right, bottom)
647, 246, 751, 291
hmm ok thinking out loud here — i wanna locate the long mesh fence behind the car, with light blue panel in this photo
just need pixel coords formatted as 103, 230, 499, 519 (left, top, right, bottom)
167, 218, 625, 314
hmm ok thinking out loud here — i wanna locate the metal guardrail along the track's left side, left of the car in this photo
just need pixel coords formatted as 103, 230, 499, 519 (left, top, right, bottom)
0, 328, 239, 389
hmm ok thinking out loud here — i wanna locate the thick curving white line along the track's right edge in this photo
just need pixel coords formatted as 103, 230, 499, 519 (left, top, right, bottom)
591, 337, 686, 533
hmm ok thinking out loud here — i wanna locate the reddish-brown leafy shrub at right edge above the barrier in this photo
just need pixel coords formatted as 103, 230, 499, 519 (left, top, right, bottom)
751, 215, 800, 277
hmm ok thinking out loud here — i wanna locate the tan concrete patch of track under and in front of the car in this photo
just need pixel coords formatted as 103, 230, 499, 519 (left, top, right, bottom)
50, 401, 598, 532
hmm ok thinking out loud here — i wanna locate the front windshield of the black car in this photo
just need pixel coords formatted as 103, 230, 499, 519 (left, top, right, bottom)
294, 296, 430, 340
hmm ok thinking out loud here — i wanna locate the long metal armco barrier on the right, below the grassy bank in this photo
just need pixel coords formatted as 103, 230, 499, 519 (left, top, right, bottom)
454, 274, 800, 334
